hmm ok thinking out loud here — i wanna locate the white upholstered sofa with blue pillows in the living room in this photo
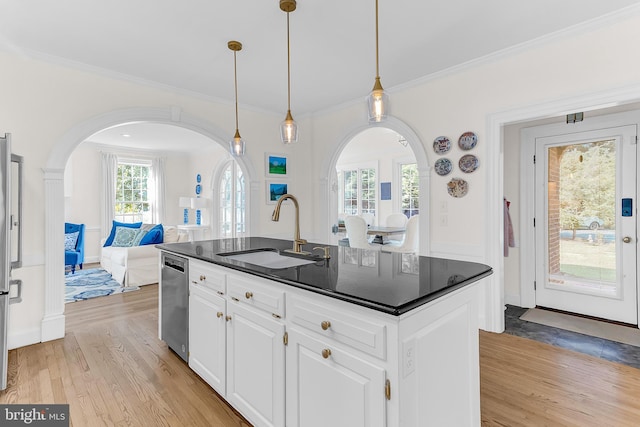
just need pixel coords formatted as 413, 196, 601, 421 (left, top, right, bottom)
100, 225, 189, 286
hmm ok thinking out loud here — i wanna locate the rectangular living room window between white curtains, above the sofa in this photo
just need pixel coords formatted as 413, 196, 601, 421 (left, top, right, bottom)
114, 160, 154, 223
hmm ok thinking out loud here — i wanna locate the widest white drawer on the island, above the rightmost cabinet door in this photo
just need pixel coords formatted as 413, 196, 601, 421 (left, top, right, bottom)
287, 297, 387, 360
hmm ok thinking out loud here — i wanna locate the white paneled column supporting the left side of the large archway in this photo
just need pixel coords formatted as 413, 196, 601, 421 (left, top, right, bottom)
41, 169, 65, 342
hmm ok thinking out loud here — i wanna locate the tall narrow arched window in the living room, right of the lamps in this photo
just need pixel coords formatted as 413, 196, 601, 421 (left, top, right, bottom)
218, 160, 246, 238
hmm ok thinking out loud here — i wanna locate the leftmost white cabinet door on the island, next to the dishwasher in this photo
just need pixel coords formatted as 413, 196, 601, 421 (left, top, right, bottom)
189, 286, 226, 396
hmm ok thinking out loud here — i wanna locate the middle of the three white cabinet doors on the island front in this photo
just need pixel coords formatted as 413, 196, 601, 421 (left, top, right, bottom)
226, 302, 285, 426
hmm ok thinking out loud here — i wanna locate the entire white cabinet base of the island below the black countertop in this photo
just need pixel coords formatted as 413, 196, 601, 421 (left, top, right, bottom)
180, 254, 480, 427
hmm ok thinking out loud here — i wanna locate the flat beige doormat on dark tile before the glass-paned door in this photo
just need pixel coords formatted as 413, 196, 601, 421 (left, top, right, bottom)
520, 308, 640, 347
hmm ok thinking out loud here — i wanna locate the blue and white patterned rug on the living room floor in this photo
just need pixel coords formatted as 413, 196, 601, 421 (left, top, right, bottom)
64, 268, 140, 303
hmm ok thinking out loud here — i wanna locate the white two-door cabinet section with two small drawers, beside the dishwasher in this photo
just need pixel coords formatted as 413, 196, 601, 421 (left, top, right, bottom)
189, 259, 285, 427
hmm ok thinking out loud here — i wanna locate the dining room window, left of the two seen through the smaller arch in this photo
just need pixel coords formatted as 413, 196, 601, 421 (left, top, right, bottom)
338, 167, 378, 216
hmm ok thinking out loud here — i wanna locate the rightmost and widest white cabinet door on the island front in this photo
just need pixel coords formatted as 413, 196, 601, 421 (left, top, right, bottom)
287, 328, 386, 427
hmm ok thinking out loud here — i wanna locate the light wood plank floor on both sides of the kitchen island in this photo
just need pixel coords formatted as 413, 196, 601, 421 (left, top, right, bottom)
0, 285, 640, 427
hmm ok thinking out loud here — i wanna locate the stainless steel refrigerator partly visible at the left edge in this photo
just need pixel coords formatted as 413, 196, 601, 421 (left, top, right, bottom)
0, 134, 22, 390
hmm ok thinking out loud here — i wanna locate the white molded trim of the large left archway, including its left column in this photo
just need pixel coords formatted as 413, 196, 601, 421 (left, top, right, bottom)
41, 107, 257, 341
